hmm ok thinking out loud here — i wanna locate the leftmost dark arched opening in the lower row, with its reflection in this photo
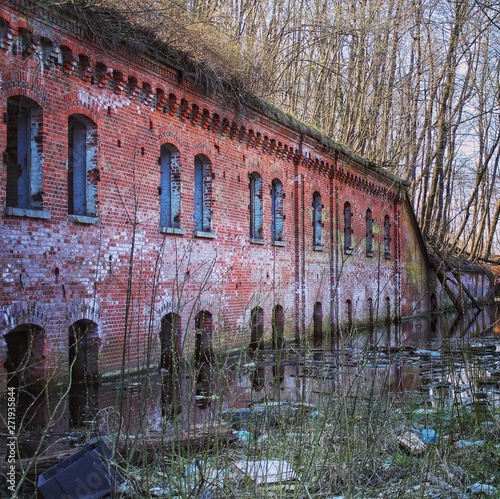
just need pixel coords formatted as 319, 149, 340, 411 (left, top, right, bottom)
3, 324, 46, 433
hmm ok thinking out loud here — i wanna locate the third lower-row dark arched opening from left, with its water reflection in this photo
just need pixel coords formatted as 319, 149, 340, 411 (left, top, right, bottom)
160, 313, 181, 418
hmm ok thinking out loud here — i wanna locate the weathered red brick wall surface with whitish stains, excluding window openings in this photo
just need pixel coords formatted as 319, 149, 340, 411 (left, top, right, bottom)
0, 2, 492, 398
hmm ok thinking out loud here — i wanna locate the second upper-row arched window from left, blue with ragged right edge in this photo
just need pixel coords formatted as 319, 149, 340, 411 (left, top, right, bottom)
68, 114, 99, 217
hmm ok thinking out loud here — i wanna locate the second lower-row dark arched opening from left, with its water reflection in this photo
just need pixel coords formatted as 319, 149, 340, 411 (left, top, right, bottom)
69, 320, 99, 427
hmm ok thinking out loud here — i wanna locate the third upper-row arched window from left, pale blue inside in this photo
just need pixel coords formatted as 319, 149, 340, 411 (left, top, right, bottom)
159, 144, 181, 229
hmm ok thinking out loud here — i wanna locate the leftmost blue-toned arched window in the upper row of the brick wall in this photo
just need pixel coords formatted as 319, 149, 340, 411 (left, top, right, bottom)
6, 96, 43, 210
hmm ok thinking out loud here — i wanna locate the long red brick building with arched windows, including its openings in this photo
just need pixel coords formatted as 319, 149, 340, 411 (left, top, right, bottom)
0, 0, 492, 426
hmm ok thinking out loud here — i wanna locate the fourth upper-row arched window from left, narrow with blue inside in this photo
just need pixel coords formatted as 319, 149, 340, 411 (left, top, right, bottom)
194, 154, 212, 232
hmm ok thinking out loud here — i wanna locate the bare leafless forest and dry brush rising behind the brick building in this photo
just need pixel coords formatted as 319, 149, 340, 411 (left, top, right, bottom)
73, 0, 500, 260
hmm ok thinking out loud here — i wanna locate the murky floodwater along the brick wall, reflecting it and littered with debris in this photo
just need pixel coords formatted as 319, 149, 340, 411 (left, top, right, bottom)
92, 300, 500, 434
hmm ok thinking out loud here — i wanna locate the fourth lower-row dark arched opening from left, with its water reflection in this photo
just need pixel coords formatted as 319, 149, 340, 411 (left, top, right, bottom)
194, 310, 213, 409
